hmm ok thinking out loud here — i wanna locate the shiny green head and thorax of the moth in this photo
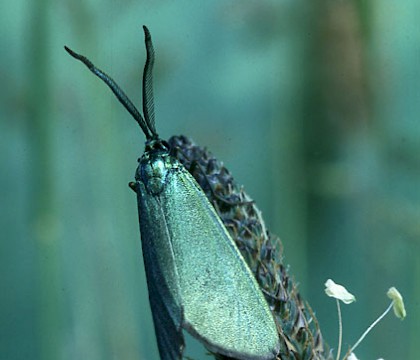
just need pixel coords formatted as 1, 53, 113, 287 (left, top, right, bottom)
136, 139, 179, 195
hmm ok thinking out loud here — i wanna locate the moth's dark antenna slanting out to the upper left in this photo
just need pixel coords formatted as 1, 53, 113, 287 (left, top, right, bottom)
64, 42, 156, 140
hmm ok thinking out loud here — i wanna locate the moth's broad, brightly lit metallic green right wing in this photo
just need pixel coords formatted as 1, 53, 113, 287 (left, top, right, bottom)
160, 167, 280, 360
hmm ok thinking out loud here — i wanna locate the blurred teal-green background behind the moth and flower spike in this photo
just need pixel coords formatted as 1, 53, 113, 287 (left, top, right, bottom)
0, 0, 420, 360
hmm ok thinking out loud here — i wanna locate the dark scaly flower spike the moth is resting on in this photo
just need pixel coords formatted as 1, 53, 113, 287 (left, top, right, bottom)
168, 136, 329, 359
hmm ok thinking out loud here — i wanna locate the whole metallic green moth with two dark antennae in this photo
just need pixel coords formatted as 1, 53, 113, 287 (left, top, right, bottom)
65, 26, 280, 360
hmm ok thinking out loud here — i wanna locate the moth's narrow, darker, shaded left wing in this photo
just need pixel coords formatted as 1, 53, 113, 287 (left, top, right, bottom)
137, 188, 184, 360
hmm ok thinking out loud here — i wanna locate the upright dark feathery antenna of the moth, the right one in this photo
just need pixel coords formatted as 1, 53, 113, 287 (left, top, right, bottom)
143, 25, 158, 138
